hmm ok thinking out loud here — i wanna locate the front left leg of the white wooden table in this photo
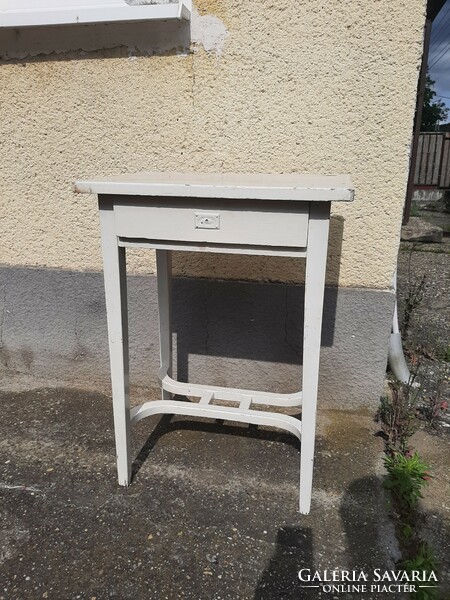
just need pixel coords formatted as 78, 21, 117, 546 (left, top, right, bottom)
99, 200, 131, 485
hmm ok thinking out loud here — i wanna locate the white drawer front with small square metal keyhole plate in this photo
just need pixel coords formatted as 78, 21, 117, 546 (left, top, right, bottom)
114, 198, 309, 248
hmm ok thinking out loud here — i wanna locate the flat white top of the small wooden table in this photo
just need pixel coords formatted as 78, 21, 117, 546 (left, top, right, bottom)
75, 172, 354, 202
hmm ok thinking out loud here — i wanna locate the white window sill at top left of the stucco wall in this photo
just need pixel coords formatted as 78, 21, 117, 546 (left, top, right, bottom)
0, 0, 192, 27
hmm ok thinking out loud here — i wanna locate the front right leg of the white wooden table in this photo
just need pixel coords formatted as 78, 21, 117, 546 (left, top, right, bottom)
300, 202, 330, 515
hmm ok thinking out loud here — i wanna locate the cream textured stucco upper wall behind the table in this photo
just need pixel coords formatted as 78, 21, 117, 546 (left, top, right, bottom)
0, 0, 424, 289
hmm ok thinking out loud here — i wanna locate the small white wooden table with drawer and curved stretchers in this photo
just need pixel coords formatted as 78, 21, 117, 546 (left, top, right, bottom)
75, 173, 353, 514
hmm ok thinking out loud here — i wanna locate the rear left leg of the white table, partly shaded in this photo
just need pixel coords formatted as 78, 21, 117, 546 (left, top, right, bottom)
156, 250, 172, 400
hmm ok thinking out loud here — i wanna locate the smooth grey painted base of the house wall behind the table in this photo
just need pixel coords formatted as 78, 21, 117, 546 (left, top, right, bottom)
0, 267, 394, 409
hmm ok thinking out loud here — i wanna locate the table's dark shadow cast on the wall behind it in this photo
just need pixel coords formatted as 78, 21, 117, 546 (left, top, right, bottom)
173, 217, 344, 382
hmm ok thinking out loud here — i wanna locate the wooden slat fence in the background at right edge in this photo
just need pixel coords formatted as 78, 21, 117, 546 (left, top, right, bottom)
414, 133, 450, 188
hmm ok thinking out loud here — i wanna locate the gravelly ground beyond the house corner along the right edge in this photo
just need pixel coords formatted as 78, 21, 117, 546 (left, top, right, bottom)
392, 236, 450, 600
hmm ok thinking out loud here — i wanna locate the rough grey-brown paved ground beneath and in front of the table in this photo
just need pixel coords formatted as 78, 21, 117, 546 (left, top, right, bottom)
0, 388, 394, 600
